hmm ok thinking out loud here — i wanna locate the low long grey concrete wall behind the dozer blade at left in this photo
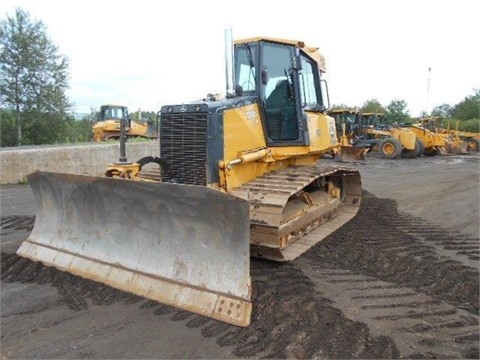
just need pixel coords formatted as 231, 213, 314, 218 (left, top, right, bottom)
0, 140, 160, 184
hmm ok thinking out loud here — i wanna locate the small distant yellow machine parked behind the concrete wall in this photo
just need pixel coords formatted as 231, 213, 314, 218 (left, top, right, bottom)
92, 104, 158, 141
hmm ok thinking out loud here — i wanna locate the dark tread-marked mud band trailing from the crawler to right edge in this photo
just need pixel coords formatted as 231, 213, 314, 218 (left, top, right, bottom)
302, 192, 480, 315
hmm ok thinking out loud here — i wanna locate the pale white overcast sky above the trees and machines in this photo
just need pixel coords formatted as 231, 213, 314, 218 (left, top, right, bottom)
0, 0, 480, 117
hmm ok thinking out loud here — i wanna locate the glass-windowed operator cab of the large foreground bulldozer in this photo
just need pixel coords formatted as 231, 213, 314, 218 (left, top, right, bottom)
234, 38, 328, 146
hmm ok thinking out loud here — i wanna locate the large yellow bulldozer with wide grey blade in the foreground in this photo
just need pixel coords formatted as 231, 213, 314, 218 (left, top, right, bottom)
17, 31, 362, 326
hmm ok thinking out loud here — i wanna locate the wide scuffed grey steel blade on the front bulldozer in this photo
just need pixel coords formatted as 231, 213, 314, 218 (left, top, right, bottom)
17, 172, 252, 326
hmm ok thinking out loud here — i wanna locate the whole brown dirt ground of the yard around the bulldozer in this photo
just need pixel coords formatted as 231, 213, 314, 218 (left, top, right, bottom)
0, 154, 480, 359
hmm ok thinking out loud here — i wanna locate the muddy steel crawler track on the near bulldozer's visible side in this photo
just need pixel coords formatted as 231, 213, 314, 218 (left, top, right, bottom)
231, 165, 362, 261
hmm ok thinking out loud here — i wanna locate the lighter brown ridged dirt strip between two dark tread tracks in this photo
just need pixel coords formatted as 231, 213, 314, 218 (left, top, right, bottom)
300, 259, 479, 359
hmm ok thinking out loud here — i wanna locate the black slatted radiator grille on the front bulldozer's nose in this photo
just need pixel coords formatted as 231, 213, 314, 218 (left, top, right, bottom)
160, 113, 207, 185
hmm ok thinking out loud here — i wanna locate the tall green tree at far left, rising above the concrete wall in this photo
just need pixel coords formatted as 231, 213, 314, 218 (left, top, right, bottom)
0, 8, 71, 145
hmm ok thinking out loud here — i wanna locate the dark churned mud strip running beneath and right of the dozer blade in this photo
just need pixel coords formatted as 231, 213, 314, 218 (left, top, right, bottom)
1, 253, 399, 359
